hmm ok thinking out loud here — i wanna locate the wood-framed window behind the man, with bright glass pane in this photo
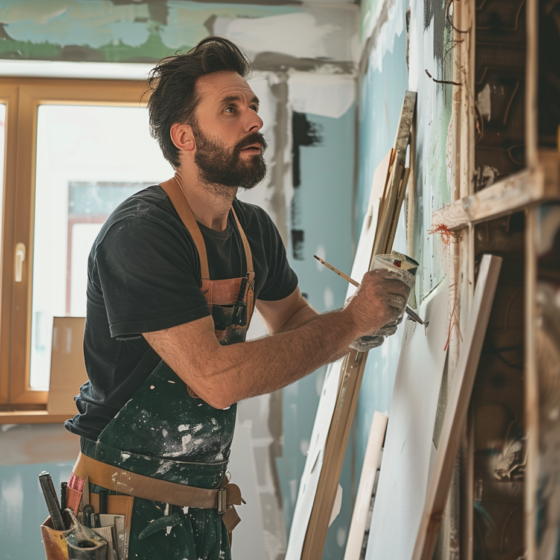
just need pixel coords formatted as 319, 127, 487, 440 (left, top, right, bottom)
0, 79, 173, 410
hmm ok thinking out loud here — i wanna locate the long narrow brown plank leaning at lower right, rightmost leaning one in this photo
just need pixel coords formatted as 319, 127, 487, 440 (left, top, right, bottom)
412, 255, 502, 560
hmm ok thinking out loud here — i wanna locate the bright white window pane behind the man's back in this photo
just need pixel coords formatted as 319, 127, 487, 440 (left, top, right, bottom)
30, 105, 173, 389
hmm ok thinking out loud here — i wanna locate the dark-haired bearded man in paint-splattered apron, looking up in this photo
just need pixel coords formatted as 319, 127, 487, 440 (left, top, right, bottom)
66, 37, 409, 560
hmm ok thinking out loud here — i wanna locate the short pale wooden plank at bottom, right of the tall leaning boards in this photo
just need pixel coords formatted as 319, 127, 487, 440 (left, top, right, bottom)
344, 411, 387, 560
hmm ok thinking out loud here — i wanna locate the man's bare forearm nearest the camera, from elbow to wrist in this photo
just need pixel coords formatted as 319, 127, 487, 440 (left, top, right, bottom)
204, 310, 359, 406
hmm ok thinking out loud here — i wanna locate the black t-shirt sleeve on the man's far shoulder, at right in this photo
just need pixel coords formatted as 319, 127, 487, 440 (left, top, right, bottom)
258, 211, 298, 301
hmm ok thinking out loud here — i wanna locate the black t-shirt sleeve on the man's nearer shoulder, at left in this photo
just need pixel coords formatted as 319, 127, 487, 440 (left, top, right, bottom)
93, 218, 210, 337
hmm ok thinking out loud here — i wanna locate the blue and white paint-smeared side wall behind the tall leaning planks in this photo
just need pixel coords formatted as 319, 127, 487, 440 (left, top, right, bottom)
354, 0, 453, 504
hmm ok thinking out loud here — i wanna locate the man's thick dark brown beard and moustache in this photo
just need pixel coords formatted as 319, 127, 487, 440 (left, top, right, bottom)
192, 124, 267, 189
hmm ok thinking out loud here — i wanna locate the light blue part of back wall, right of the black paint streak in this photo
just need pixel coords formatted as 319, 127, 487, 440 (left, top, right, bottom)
278, 105, 355, 560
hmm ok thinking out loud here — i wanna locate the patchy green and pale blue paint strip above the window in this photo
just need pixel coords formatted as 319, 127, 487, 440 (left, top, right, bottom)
0, 0, 302, 63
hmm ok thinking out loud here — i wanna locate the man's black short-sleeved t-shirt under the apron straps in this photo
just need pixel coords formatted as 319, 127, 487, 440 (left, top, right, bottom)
66, 186, 297, 440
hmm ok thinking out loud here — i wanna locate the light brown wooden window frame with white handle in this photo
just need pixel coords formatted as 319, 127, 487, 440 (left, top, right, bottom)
0, 78, 148, 423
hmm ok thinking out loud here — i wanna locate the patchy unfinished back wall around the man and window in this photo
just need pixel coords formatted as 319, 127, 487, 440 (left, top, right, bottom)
0, 0, 359, 560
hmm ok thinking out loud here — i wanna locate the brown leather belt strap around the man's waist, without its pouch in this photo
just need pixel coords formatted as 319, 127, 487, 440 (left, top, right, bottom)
73, 453, 245, 533
